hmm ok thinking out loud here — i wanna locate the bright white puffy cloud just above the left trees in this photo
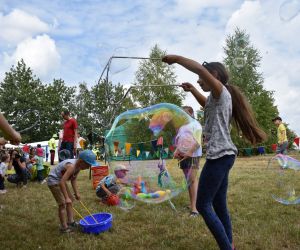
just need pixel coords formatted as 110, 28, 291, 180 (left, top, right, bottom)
5, 35, 60, 79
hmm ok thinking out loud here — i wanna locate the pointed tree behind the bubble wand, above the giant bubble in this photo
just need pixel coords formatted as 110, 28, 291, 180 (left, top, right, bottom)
132, 45, 185, 107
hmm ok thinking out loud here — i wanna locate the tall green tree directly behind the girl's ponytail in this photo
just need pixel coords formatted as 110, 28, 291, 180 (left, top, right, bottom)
224, 29, 278, 147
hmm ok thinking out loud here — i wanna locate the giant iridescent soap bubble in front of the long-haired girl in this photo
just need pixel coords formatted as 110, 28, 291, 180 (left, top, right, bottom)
105, 103, 202, 207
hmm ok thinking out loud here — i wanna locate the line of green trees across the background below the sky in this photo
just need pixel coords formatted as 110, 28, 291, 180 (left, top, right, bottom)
0, 29, 295, 147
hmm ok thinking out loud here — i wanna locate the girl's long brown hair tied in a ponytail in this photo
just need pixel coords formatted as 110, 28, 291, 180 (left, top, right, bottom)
202, 62, 267, 144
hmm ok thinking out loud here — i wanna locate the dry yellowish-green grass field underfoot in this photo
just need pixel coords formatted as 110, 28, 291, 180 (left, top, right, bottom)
0, 155, 300, 250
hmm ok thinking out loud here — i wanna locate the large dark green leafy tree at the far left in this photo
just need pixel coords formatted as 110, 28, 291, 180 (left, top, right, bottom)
0, 60, 75, 142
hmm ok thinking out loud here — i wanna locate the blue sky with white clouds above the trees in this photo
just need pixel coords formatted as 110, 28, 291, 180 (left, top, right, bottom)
0, 0, 300, 135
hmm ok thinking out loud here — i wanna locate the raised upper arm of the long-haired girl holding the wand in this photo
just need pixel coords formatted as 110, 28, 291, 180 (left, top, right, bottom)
162, 55, 223, 98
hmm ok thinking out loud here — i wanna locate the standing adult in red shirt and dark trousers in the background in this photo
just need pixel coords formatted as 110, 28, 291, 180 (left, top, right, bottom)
59, 110, 78, 161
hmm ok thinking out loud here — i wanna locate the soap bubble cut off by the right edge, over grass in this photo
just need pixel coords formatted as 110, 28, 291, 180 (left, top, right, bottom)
268, 154, 300, 205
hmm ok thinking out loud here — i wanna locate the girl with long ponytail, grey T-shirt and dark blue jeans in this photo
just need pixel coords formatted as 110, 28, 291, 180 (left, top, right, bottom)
162, 55, 266, 250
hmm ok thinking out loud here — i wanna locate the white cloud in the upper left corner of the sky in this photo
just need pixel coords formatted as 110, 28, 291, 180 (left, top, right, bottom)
0, 9, 49, 45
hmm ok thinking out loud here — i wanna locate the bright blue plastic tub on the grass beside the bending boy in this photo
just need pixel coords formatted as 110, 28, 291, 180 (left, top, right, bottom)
79, 213, 112, 234
